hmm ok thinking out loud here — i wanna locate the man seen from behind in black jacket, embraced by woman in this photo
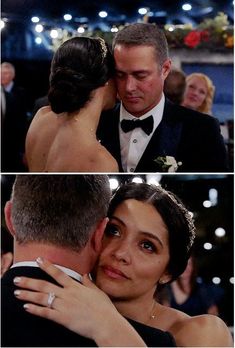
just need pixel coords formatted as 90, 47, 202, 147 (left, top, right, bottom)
1, 175, 174, 347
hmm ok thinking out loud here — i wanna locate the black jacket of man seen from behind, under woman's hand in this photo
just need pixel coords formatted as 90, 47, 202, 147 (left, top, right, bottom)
1, 267, 175, 347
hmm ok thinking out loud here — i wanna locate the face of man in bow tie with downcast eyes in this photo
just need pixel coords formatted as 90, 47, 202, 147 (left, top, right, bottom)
114, 44, 171, 117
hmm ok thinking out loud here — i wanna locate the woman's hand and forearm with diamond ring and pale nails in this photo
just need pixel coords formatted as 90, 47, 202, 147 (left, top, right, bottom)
14, 259, 146, 347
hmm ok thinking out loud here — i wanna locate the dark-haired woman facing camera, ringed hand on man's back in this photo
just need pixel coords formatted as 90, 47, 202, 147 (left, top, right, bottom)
13, 182, 232, 347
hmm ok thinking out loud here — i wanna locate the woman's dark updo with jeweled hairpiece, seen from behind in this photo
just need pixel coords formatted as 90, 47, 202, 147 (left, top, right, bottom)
48, 37, 115, 114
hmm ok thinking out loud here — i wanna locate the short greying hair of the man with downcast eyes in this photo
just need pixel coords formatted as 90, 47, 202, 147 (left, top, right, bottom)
113, 23, 169, 66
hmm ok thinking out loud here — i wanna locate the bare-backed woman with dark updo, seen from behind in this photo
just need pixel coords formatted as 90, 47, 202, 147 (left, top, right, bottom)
26, 37, 118, 172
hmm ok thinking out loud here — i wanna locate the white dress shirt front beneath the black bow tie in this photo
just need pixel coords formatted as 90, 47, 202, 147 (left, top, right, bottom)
119, 94, 165, 172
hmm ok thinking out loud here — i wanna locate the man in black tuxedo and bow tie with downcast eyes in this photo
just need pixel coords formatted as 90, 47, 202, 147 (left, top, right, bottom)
97, 23, 228, 172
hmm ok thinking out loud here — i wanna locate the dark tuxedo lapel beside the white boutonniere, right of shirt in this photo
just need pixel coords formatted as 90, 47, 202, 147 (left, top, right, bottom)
135, 101, 183, 172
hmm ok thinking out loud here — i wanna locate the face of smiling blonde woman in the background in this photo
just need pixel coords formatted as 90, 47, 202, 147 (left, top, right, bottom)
183, 76, 208, 110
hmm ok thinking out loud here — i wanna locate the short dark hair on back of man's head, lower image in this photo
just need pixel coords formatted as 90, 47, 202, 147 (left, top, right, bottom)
11, 175, 111, 251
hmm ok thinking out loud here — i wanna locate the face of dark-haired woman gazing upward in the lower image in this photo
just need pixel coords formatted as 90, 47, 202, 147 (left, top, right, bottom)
96, 199, 169, 300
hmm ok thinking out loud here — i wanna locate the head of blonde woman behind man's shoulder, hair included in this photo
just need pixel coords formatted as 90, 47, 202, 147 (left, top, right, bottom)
182, 73, 215, 115
